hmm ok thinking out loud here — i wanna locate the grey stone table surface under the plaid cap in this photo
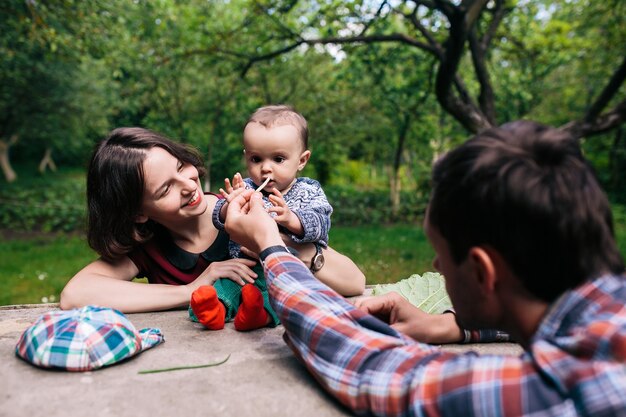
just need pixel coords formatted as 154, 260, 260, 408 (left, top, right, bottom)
0, 304, 521, 417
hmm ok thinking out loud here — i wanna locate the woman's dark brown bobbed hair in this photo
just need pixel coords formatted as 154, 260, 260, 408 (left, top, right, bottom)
87, 127, 206, 260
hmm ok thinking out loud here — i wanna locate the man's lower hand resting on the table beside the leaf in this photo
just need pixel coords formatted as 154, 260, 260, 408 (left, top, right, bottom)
354, 292, 463, 344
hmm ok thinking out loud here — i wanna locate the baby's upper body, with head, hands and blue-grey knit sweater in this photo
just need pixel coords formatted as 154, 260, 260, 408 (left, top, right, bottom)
213, 105, 333, 272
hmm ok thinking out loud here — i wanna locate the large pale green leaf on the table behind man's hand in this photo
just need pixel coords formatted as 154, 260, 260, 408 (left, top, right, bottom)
372, 272, 452, 314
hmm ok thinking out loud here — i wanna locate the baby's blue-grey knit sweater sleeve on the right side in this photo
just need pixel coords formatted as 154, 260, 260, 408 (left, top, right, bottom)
289, 180, 333, 247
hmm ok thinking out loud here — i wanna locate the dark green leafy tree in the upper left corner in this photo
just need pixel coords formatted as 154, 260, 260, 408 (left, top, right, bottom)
0, 0, 113, 182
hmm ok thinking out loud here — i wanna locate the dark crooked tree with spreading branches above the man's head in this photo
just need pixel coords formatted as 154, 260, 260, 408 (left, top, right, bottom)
229, 0, 626, 138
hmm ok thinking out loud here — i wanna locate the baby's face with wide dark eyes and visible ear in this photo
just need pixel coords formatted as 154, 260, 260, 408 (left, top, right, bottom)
243, 123, 310, 193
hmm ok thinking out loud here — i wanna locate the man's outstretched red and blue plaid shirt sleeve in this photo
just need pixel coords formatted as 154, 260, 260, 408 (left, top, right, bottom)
264, 253, 564, 417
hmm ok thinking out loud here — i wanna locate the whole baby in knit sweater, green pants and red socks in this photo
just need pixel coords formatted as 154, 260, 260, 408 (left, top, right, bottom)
189, 105, 336, 330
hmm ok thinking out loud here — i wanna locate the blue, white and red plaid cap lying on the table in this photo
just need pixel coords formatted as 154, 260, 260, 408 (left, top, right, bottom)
15, 306, 164, 371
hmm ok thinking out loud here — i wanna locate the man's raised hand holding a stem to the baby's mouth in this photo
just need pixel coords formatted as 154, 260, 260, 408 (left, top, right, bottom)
225, 190, 284, 254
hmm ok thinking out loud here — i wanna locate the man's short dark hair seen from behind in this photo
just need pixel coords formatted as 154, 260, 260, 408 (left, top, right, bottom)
428, 121, 624, 302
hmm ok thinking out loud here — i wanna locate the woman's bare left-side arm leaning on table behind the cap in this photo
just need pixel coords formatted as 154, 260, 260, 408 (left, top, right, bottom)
60, 256, 199, 313
